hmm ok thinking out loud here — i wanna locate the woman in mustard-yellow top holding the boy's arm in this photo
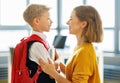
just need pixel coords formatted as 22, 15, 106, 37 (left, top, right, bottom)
39, 5, 103, 83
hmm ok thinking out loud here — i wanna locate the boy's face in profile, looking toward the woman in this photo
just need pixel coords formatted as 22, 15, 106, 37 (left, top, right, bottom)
34, 11, 52, 32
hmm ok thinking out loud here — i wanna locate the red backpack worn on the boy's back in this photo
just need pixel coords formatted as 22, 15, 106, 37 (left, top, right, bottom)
11, 35, 48, 83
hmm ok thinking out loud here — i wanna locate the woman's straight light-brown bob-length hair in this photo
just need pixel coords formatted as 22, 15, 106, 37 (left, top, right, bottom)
74, 5, 103, 43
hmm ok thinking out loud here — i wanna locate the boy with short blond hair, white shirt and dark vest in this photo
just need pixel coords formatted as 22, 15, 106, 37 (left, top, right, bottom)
23, 4, 58, 83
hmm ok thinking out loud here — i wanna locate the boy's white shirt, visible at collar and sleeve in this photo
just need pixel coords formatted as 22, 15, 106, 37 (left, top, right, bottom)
29, 31, 50, 64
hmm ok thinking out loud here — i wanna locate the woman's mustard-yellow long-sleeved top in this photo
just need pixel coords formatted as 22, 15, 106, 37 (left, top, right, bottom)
65, 43, 100, 83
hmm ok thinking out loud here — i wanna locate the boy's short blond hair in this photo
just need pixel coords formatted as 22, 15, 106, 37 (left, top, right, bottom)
23, 4, 49, 25
